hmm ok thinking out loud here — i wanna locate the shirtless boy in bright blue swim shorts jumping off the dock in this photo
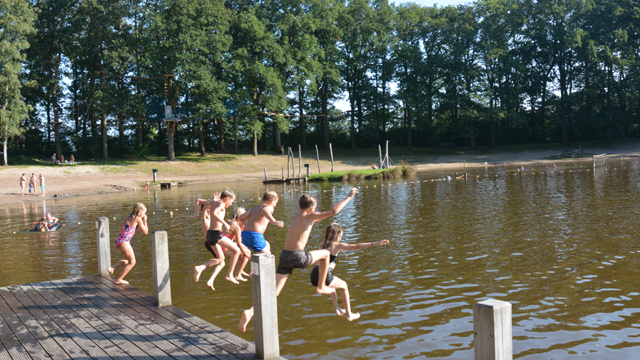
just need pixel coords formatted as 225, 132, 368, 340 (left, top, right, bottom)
238, 190, 284, 254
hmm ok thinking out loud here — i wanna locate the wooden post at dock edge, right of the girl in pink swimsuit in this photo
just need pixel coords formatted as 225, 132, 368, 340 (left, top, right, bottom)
151, 231, 171, 307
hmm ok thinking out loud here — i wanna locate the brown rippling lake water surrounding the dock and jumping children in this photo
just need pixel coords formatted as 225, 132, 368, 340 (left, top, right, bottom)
0, 162, 640, 359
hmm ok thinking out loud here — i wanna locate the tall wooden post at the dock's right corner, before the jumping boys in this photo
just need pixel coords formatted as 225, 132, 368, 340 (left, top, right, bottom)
251, 254, 280, 360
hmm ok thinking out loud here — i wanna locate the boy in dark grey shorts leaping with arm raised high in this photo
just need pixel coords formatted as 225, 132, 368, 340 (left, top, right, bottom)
238, 188, 358, 332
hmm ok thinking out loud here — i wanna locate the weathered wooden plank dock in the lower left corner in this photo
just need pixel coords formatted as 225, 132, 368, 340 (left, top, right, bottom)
0, 276, 276, 360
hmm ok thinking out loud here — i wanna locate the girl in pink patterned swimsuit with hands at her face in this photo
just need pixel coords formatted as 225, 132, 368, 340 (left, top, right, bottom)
107, 203, 149, 285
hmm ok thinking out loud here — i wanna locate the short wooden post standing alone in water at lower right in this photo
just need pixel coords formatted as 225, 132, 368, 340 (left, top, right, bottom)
473, 299, 513, 360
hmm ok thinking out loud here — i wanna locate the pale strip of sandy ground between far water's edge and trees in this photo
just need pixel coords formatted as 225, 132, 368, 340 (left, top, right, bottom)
0, 143, 640, 205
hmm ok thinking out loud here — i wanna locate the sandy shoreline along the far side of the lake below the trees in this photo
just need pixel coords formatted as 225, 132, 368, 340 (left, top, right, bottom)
0, 143, 640, 205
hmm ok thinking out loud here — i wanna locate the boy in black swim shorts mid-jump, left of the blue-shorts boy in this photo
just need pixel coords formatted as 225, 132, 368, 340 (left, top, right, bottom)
193, 189, 240, 290
